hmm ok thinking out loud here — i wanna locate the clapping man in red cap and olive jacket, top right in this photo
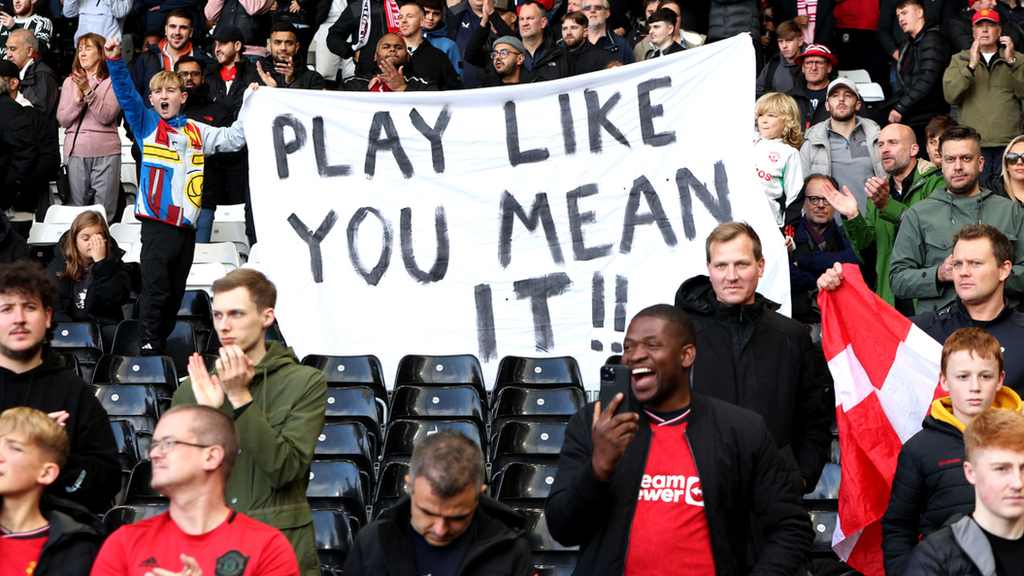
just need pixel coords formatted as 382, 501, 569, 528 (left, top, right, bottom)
942, 9, 1024, 181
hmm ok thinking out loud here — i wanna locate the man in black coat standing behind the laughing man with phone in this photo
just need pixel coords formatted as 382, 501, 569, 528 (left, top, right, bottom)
676, 222, 831, 492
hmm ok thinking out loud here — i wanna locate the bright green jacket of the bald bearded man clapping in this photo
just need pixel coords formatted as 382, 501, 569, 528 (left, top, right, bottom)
843, 159, 946, 306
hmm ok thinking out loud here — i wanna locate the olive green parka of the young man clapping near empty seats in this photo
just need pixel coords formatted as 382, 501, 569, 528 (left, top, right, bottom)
171, 341, 327, 530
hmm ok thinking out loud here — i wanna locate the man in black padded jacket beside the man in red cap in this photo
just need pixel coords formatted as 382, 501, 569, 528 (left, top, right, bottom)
889, 0, 951, 150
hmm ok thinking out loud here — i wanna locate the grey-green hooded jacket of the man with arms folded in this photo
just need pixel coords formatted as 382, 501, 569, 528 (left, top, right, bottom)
889, 189, 1024, 314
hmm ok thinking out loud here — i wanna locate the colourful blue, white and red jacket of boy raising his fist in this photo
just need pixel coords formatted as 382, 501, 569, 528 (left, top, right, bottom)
106, 57, 246, 229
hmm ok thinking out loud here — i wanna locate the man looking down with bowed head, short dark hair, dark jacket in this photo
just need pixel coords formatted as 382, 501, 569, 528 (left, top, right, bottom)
342, 430, 535, 576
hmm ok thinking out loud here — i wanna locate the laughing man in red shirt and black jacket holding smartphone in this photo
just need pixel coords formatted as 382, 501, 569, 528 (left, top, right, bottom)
545, 304, 814, 576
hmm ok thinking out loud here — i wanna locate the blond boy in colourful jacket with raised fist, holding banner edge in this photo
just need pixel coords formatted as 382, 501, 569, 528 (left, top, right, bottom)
103, 38, 246, 355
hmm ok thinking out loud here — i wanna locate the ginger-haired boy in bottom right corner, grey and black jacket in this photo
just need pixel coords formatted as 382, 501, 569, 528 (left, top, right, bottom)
904, 410, 1024, 576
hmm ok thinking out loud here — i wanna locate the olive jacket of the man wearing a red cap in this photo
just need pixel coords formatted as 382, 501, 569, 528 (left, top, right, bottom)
942, 49, 1024, 147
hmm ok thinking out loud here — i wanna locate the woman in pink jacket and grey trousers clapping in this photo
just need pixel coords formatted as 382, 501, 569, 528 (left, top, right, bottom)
57, 34, 121, 219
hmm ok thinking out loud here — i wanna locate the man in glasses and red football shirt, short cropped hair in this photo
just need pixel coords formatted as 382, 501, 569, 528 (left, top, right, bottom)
92, 404, 299, 576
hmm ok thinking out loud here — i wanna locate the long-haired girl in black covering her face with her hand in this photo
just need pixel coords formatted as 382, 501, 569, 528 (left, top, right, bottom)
48, 210, 131, 348
